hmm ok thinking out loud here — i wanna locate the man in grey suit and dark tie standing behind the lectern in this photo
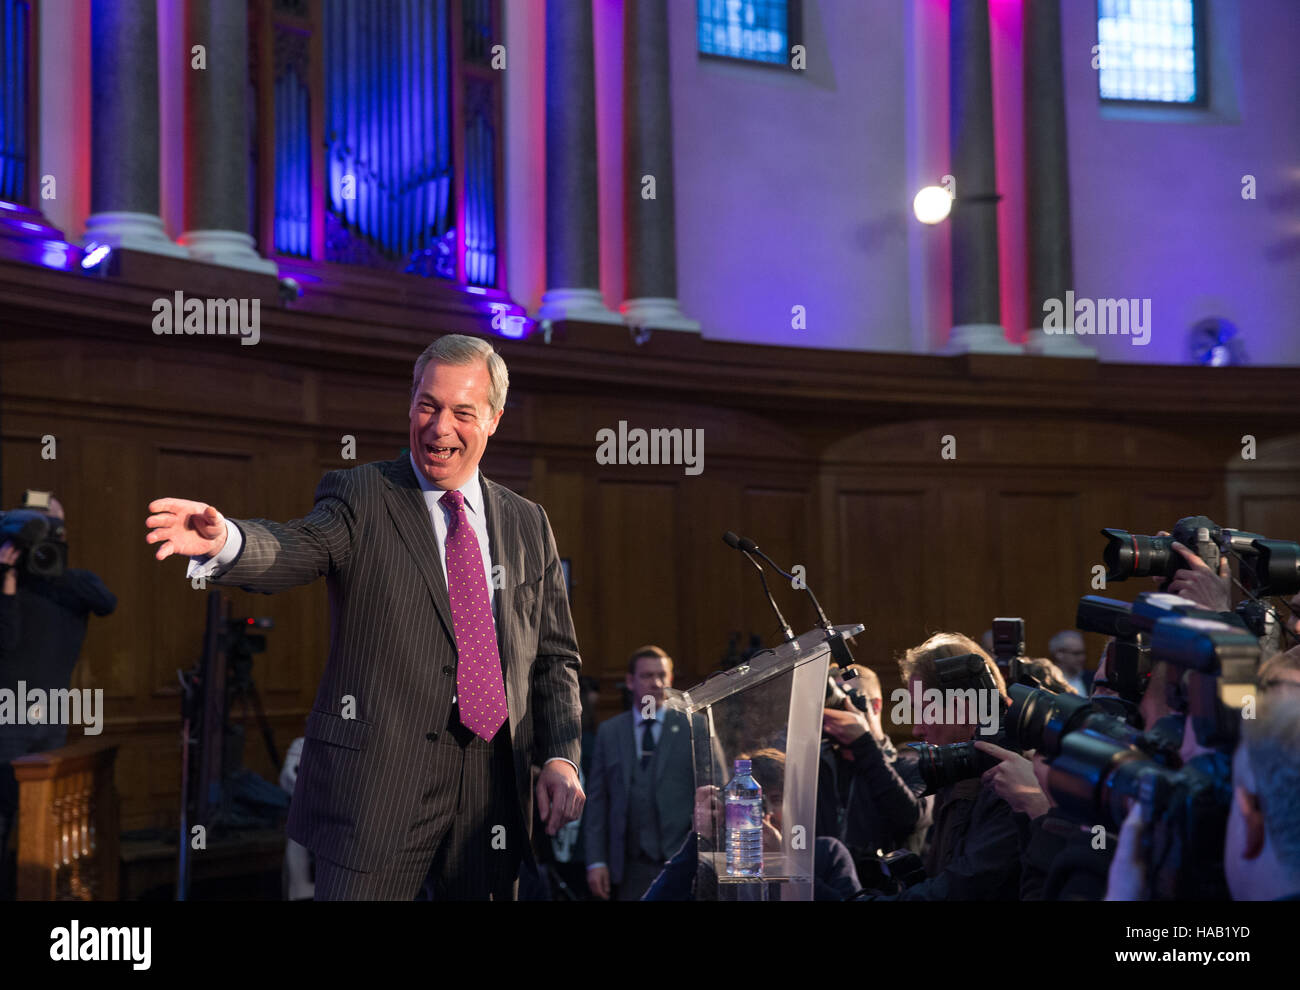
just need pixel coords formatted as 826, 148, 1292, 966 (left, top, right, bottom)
584, 646, 696, 900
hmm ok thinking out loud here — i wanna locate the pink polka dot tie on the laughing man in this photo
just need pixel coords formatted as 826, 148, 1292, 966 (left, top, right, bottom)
438, 491, 510, 742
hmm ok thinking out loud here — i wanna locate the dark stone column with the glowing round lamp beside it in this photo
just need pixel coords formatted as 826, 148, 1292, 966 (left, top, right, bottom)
948, 0, 1021, 353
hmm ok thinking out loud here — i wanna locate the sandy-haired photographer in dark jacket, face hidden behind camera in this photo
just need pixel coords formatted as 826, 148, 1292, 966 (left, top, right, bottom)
875, 633, 1021, 900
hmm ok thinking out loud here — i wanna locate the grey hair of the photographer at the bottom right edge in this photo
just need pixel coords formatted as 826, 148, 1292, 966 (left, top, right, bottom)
1244, 696, 1300, 880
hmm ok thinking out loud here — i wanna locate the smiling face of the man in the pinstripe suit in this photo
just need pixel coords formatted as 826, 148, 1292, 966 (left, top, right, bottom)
410, 361, 501, 491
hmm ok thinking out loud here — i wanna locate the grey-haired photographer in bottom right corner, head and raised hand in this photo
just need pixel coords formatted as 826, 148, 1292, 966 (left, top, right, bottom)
1106, 691, 1300, 900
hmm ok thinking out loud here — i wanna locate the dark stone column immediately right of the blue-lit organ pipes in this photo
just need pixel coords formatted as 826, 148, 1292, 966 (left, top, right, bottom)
537, 0, 621, 324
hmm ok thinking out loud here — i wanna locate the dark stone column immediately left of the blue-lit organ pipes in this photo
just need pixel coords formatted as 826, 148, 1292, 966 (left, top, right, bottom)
179, 0, 276, 275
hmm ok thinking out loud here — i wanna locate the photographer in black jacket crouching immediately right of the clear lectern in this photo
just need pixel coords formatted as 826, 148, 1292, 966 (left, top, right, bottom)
818, 664, 933, 860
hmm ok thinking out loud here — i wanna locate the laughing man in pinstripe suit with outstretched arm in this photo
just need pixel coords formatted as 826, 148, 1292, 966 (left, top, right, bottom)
146, 334, 585, 899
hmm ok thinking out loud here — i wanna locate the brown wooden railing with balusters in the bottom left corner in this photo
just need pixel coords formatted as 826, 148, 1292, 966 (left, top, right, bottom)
13, 738, 120, 900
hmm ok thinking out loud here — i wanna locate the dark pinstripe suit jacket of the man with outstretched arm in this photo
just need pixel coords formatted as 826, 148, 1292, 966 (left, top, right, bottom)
209, 455, 581, 872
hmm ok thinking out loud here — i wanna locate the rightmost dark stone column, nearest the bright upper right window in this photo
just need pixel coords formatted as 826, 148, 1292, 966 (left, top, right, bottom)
1024, 0, 1097, 357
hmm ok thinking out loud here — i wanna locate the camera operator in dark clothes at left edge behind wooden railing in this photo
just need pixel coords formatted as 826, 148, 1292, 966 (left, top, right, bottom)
0, 492, 117, 899
